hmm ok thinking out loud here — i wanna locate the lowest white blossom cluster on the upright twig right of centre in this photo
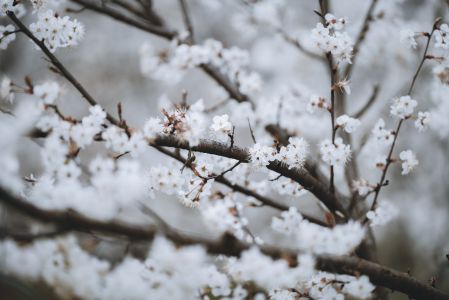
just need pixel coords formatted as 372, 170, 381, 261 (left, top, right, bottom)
320, 138, 351, 166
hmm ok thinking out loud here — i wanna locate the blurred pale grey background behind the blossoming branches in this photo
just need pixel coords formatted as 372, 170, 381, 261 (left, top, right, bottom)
0, 0, 449, 299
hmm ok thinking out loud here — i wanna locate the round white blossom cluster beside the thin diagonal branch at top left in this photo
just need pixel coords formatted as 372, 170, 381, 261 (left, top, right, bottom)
30, 10, 84, 52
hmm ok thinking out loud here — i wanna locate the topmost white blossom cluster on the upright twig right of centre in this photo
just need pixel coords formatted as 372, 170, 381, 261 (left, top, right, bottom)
312, 14, 353, 63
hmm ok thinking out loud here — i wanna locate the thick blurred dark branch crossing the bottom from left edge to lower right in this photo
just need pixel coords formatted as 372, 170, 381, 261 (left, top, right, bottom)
0, 187, 449, 300
